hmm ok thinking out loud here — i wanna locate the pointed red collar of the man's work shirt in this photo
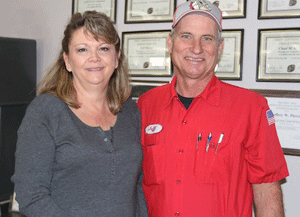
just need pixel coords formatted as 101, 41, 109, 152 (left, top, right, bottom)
165, 75, 221, 107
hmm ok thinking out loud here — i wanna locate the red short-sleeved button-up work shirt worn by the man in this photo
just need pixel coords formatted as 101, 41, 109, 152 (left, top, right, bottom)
138, 76, 288, 217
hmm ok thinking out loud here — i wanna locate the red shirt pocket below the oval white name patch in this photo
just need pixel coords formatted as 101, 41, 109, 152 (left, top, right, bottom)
143, 135, 166, 186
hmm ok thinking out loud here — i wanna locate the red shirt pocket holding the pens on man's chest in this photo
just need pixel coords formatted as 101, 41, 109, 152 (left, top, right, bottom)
194, 142, 229, 184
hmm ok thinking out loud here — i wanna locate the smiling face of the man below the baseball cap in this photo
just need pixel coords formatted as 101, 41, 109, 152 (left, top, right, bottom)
168, 14, 224, 81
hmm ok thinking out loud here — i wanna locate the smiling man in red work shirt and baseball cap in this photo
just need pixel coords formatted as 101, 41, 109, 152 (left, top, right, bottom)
138, 0, 288, 217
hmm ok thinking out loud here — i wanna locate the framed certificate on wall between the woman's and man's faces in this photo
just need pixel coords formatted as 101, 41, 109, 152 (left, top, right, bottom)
122, 30, 171, 76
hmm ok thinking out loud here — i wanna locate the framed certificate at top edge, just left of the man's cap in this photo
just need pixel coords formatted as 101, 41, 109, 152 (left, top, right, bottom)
125, 0, 176, 23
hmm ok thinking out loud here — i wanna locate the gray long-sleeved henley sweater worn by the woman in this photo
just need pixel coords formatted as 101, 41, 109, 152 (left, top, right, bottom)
12, 94, 148, 217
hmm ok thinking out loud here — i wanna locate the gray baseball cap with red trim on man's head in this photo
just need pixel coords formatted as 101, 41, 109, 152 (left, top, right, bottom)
172, 0, 222, 31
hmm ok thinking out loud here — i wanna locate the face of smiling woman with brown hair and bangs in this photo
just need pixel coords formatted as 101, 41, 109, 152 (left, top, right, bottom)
63, 28, 119, 89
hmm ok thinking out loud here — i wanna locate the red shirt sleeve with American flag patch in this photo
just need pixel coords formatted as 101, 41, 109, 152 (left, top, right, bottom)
245, 98, 289, 184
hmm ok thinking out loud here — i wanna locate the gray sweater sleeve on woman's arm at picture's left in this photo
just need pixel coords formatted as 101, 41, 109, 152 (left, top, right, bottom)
12, 98, 69, 217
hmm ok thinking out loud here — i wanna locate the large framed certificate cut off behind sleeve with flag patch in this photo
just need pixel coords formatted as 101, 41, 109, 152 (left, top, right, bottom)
253, 90, 300, 156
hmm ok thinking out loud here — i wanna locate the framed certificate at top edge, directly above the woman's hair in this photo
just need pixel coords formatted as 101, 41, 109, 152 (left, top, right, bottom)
72, 0, 117, 23
